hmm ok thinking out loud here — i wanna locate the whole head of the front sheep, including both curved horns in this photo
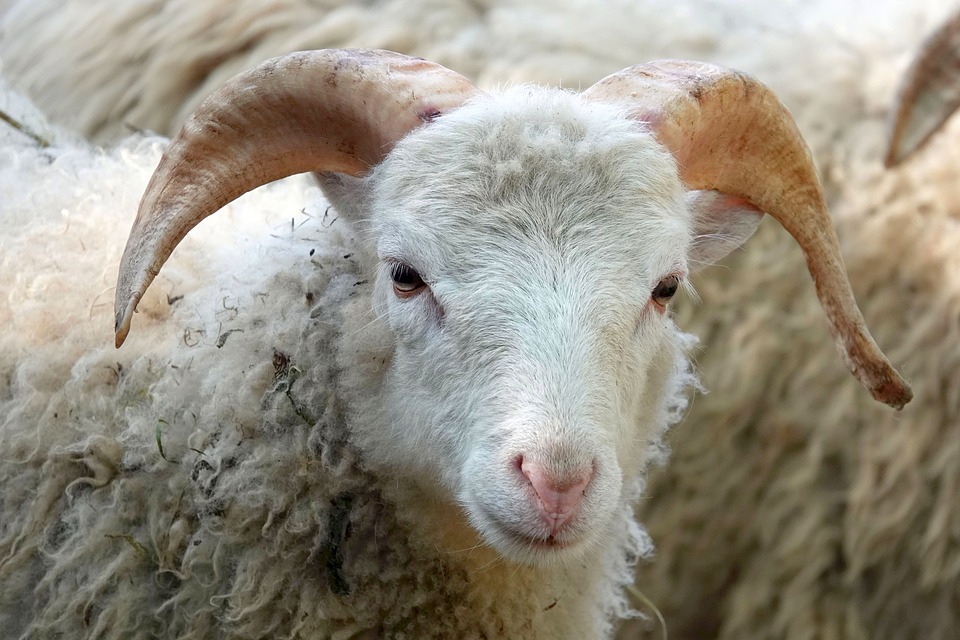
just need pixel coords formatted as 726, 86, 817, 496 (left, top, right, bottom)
117, 51, 910, 563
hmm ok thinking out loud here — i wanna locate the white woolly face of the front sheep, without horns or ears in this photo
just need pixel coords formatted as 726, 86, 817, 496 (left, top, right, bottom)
342, 88, 693, 563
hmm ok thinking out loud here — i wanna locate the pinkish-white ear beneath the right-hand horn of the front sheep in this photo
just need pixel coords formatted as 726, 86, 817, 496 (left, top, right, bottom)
686, 190, 763, 271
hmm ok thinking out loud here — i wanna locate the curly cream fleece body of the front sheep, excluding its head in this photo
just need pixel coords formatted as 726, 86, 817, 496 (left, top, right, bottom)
0, 82, 704, 638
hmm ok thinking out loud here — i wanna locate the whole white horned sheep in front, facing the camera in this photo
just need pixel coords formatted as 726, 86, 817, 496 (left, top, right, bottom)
0, 50, 911, 638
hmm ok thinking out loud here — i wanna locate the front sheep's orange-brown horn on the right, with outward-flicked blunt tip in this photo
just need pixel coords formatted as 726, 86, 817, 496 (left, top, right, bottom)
584, 60, 913, 408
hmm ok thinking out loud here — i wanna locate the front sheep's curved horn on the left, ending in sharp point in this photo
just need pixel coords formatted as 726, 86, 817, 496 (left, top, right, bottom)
115, 49, 479, 347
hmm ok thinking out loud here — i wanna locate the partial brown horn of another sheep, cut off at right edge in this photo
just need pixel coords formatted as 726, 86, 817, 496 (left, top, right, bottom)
883, 12, 960, 167
